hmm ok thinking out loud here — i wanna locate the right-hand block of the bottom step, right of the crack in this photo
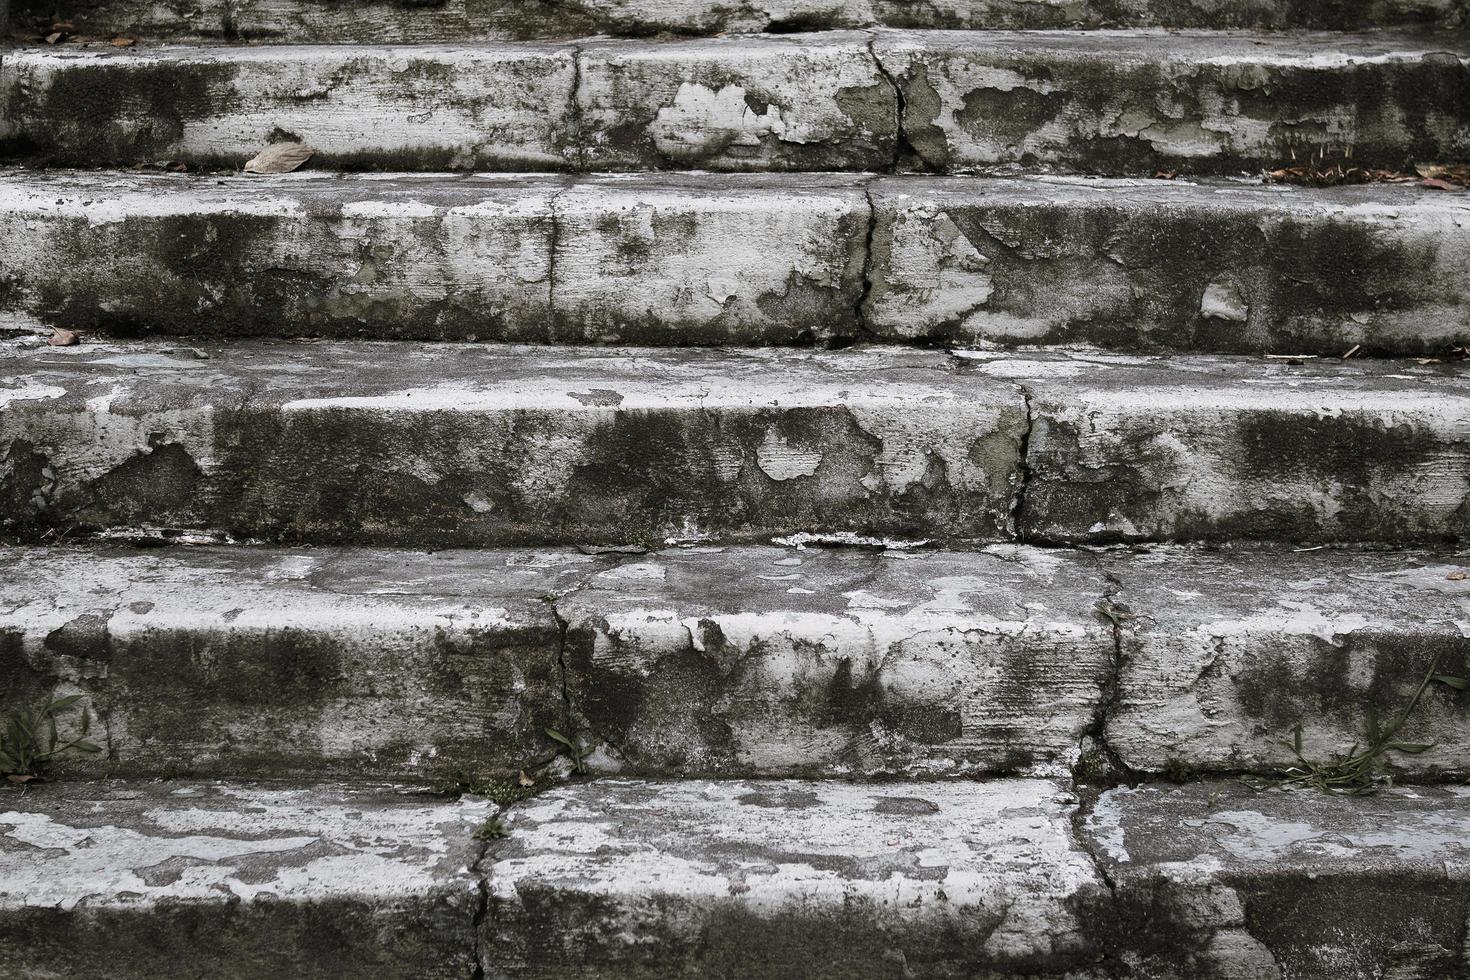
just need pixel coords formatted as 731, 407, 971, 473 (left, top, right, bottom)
1083, 783, 1470, 980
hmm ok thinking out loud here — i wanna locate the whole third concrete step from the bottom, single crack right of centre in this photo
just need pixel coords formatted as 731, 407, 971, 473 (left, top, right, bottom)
0, 339, 1470, 547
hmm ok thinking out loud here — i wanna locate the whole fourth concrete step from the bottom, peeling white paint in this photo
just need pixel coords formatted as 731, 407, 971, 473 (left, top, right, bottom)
0, 170, 1470, 356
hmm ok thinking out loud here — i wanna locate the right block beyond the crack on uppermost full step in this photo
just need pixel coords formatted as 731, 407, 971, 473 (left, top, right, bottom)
873, 31, 1470, 175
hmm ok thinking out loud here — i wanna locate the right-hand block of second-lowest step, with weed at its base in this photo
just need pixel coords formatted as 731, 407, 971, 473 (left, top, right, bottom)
1103, 548, 1470, 782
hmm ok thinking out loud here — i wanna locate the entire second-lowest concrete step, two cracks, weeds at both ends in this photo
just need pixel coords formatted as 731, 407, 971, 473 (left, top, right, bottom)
0, 545, 1470, 782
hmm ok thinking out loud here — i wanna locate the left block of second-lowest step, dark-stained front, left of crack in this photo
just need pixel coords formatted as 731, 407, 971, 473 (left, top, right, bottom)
0, 547, 607, 780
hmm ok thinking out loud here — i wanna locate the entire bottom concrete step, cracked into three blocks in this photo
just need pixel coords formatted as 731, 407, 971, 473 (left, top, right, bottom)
0, 780, 1470, 980
